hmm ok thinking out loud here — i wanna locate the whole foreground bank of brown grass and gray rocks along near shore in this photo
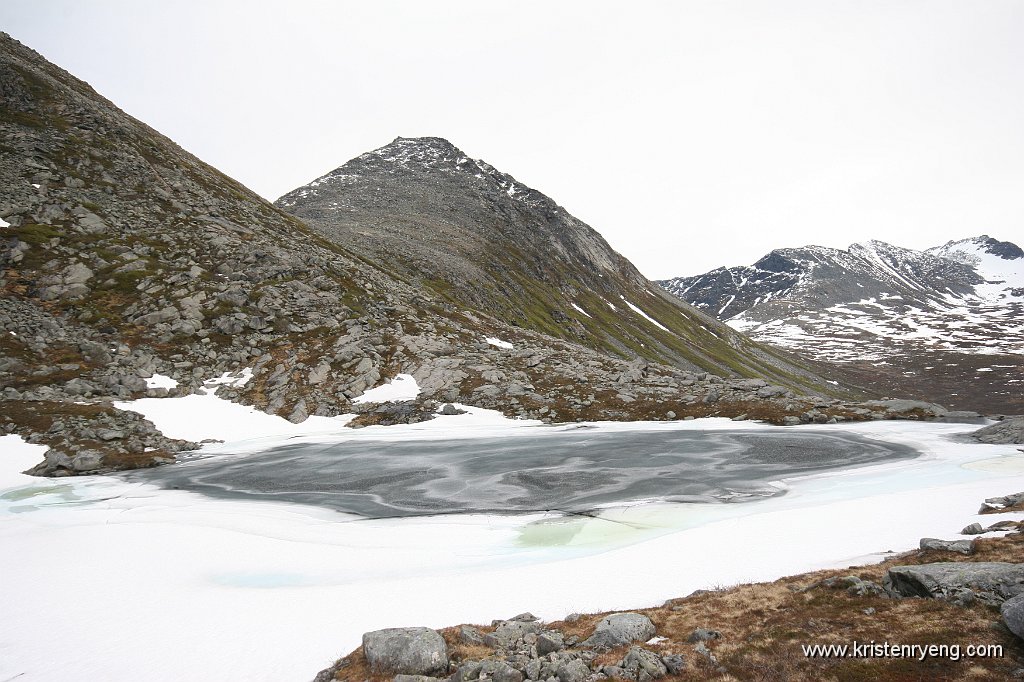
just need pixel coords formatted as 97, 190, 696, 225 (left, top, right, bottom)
314, 485, 1024, 682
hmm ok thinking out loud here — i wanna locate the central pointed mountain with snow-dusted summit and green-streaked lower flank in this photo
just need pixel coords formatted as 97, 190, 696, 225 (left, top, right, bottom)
275, 137, 821, 387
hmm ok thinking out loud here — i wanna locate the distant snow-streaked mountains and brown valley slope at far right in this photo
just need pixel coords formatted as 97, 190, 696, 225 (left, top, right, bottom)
659, 236, 1024, 412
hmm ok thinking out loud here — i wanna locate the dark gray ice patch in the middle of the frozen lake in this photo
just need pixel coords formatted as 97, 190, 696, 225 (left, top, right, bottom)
123, 427, 918, 518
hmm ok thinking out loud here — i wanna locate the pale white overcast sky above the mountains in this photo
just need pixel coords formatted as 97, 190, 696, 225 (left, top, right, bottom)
0, 0, 1024, 278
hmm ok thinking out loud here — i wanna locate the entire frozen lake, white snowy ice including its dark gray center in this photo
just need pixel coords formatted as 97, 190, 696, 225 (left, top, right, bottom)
0, 403, 1024, 682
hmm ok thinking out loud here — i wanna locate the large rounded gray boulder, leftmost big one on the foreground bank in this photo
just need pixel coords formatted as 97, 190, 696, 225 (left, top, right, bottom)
362, 628, 449, 676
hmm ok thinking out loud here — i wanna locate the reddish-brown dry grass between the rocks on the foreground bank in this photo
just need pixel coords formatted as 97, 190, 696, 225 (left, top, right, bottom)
323, 524, 1024, 682
